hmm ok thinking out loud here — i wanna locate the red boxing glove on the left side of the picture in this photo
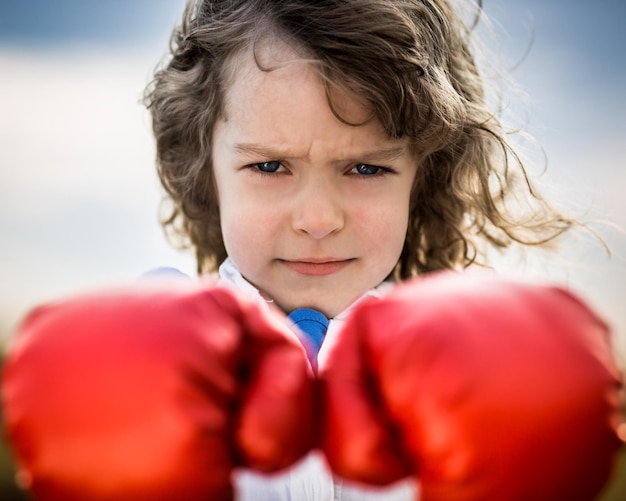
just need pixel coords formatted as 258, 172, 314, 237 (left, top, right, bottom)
2, 284, 315, 501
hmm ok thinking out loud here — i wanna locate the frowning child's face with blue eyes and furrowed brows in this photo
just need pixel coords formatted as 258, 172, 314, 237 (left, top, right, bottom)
213, 46, 417, 317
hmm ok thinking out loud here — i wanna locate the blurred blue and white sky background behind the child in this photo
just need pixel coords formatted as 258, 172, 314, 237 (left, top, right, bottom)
0, 0, 626, 501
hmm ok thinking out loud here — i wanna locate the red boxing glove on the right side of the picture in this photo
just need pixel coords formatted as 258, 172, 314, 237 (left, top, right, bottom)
319, 272, 621, 501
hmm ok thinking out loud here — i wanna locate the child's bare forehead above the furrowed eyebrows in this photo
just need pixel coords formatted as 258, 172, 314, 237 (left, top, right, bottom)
218, 41, 406, 160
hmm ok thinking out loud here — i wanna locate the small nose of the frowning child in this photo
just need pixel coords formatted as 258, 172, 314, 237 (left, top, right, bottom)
292, 178, 345, 240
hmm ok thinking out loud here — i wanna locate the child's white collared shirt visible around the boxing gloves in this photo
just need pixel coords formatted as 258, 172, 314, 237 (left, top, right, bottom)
218, 259, 418, 501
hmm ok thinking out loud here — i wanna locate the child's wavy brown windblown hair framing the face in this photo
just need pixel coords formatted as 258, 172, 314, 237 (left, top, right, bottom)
145, 0, 574, 279
